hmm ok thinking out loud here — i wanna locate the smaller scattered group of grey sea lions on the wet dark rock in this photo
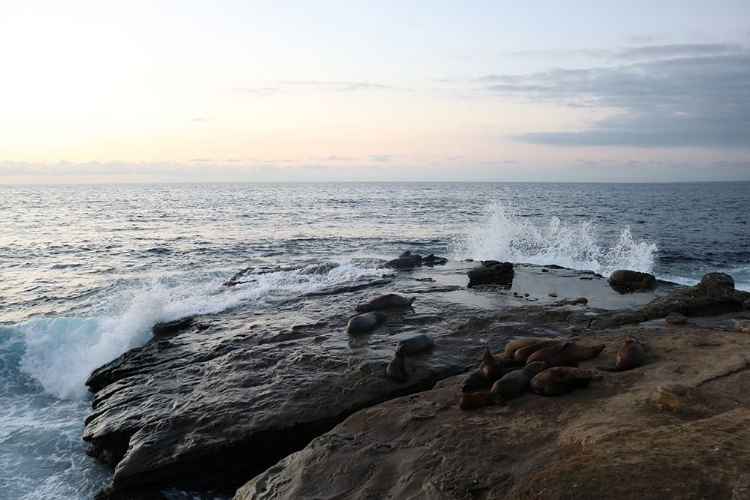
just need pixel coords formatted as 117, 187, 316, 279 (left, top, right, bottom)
346, 293, 435, 382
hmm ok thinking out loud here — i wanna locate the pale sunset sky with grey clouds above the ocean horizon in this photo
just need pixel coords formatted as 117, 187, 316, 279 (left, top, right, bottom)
0, 0, 750, 184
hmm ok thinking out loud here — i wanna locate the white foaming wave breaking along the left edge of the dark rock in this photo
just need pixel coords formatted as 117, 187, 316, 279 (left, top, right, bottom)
14, 263, 383, 399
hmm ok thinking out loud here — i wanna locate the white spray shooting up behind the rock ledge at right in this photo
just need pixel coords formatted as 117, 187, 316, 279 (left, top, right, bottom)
451, 204, 657, 276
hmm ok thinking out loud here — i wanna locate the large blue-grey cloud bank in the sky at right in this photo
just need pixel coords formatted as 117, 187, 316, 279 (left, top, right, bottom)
476, 49, 750, 148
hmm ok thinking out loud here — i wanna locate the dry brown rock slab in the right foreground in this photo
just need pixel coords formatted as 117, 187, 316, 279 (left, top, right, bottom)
236, 313, 750, 500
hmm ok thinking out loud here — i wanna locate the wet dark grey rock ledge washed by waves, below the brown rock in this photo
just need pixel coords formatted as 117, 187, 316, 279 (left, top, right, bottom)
84, 263, 670, 498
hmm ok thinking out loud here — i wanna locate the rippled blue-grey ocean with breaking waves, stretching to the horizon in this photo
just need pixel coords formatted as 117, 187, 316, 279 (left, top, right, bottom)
0, 182, 750, 499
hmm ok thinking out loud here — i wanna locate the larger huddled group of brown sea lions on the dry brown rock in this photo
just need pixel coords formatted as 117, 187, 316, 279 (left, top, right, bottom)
458, 335, 645, 410
